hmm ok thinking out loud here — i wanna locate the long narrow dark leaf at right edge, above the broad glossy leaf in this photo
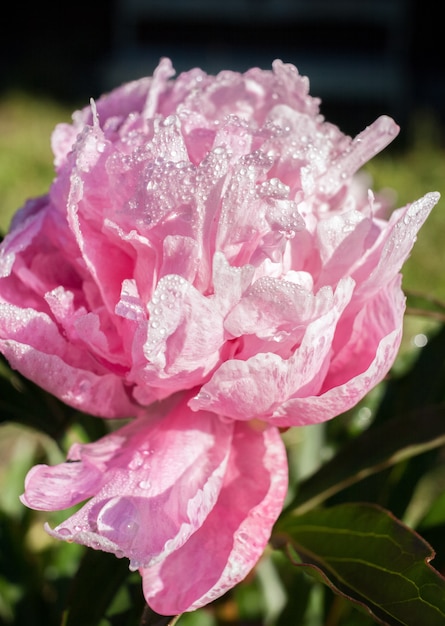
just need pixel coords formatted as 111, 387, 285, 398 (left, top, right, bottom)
287, 405, 445, 513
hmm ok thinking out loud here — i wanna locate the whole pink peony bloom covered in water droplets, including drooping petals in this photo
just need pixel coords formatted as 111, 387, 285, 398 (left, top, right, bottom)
0, 59, 438, 614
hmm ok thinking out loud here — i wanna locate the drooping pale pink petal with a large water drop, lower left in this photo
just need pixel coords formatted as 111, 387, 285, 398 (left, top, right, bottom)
23, 401, 234, 569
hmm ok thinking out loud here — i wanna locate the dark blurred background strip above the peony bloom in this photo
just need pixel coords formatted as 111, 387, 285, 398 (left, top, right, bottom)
0, 0, 445, 133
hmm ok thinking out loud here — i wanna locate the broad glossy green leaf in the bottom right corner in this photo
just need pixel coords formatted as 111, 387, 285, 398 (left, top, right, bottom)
273, 503, 445, 626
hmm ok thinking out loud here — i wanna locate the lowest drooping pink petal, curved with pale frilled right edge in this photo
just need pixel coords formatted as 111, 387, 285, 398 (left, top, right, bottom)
141, 416, 287, 615
